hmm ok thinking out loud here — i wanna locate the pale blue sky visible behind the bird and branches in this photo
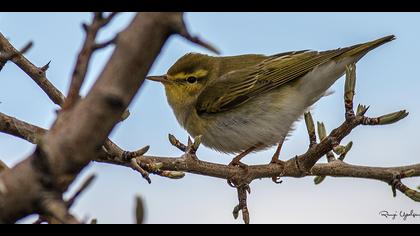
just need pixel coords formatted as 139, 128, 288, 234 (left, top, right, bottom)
0, 13, 420, 223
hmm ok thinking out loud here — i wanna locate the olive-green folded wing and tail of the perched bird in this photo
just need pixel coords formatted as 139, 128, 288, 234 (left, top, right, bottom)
196, 35, 395, 114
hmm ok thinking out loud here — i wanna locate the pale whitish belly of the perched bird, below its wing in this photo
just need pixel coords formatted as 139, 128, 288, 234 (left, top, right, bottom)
186, 87, 307, 153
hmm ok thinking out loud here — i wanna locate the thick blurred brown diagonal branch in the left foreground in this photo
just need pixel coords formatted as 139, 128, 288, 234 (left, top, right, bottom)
0, 13, 182, 222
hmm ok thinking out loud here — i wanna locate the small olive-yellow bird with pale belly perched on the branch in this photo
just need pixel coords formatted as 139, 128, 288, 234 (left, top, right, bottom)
147, 35, 395, 166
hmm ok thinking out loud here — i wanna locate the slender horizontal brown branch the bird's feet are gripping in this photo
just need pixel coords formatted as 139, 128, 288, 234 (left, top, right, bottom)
0, 113, 420, 189
